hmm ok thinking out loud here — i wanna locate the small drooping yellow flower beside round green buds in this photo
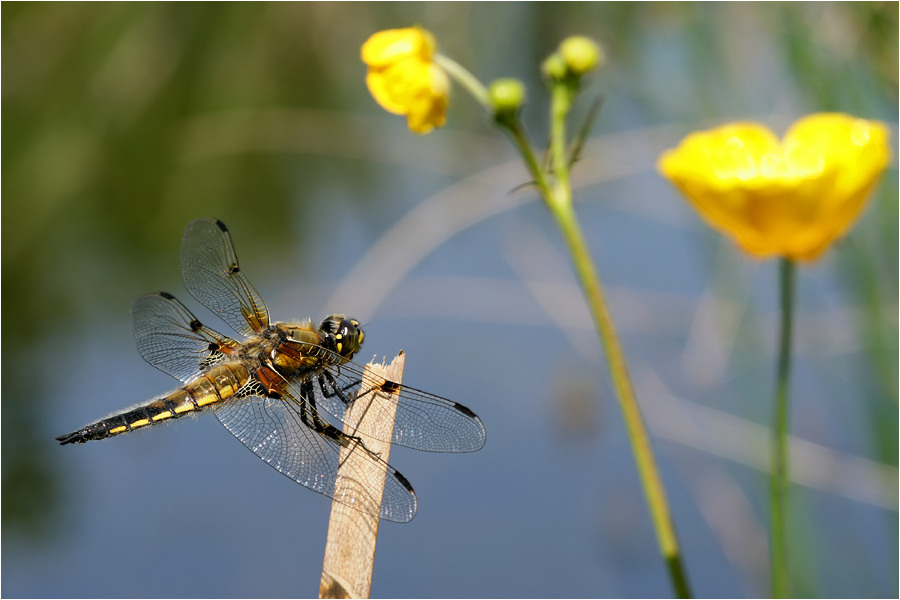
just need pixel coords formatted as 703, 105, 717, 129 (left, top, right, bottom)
362, 27, 450, 133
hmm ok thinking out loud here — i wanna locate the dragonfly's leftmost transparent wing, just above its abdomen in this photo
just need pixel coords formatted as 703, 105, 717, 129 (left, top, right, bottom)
131, 292, 238, 382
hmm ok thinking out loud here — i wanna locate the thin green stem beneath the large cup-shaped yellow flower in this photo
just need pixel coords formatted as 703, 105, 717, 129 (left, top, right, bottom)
772, 258, 796, 598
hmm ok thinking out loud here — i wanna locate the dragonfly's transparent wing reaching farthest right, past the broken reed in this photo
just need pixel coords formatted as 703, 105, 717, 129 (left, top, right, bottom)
290, 354, 487, 452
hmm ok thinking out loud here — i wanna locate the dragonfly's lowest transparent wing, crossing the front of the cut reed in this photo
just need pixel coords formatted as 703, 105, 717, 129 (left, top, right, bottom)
215, 395, 417, 523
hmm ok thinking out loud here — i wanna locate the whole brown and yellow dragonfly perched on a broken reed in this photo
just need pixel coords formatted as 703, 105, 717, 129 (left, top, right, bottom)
56, 219, 486, 523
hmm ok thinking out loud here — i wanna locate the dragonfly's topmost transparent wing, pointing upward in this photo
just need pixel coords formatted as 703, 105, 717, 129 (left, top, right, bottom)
181, 219, 269, 337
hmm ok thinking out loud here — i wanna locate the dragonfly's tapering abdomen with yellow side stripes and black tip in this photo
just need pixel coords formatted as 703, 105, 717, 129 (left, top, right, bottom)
56, 363, 250, 444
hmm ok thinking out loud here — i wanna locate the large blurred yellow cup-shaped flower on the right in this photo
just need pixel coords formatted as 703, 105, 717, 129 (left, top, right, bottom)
658, 113, 890, 260
